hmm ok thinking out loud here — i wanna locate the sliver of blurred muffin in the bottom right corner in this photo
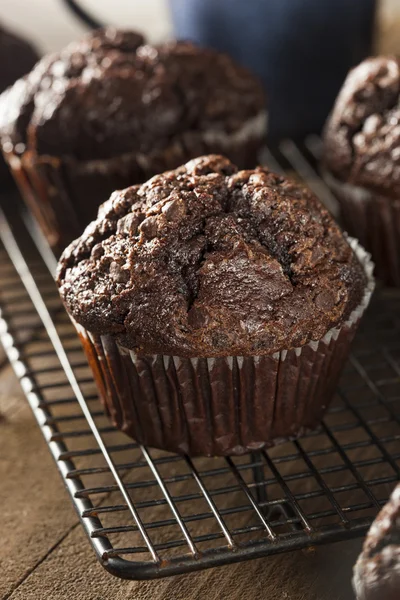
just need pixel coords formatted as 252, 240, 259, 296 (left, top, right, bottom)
353, 483, 400, 600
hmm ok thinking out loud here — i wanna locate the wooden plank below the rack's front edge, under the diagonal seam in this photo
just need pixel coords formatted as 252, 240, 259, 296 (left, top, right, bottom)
6, 527, 360, 600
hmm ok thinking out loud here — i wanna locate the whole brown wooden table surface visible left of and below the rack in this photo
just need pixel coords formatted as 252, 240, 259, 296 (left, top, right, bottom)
0, 358, 361, 600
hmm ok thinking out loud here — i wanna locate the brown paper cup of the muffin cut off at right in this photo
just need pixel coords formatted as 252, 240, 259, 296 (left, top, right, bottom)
325, 173, 400, 287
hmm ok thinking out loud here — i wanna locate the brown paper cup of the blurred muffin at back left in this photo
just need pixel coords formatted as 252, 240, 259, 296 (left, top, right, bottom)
4, 112, 267, 255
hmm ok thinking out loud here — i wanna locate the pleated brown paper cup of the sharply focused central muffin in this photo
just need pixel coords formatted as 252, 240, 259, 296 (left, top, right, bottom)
75, 239, 374, 456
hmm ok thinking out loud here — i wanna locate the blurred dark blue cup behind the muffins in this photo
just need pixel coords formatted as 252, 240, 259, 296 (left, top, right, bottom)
170, 0, 376, 139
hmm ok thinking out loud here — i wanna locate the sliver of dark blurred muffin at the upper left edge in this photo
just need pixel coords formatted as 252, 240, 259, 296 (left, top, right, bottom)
0, 26, 39, 183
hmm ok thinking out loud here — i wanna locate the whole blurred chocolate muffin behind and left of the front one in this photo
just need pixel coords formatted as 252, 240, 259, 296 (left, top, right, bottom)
0, 28, 266, 249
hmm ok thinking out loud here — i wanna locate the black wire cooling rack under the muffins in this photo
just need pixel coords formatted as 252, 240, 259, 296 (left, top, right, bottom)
0, 138, 400, 579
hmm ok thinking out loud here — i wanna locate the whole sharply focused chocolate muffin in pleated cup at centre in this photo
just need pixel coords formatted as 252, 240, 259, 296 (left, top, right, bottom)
57, 155, 373, 455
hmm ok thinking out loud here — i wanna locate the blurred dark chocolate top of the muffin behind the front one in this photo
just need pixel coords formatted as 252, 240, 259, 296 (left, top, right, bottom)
0, 28, 265, 160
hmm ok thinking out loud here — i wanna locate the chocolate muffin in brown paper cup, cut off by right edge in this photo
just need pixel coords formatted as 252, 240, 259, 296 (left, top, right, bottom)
324, 56, 400, 286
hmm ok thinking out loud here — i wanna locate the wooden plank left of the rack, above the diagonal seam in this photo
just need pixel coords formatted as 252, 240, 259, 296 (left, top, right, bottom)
0, 366, 77, 598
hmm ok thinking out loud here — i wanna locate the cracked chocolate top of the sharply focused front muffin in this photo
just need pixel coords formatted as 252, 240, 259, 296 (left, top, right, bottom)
58, 155, 365, 357
